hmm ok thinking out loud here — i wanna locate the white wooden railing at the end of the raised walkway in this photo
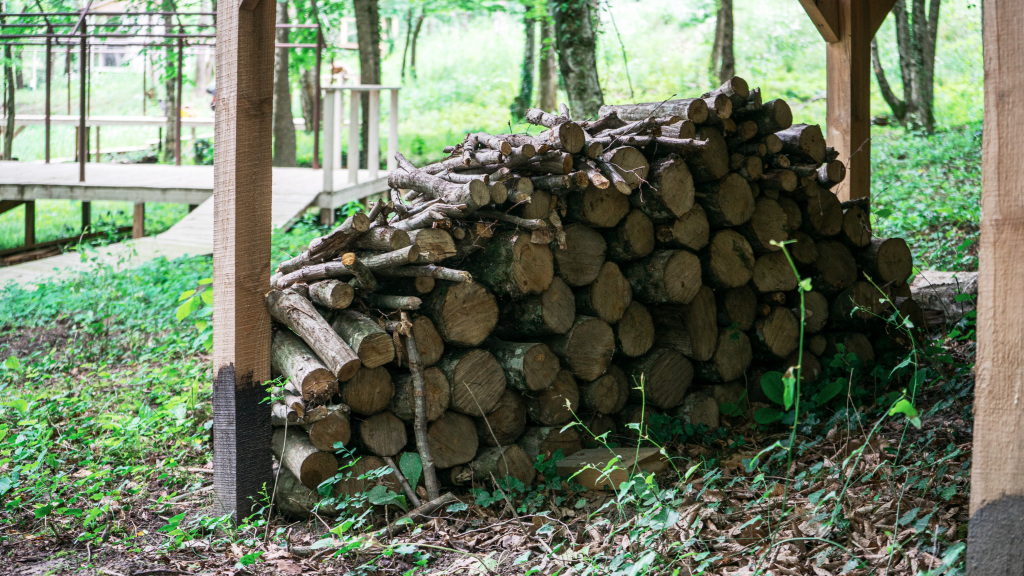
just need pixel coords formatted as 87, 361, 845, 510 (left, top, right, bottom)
323, 84, 401, 192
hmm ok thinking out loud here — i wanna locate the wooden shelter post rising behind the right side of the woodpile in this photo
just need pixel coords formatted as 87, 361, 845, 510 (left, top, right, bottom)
825, 0, 873, 201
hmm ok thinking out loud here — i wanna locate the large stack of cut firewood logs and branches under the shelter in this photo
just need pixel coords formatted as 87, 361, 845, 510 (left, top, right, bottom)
267, 78, 921, 502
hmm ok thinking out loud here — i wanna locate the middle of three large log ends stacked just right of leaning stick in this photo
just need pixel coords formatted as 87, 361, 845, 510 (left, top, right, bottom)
437, 348, 505, 414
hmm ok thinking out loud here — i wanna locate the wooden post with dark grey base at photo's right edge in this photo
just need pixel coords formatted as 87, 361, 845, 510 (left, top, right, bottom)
967, 0, 1024, 576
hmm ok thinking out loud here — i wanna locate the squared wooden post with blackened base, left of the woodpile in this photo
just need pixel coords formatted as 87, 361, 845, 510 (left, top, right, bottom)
213, 0, 275, 519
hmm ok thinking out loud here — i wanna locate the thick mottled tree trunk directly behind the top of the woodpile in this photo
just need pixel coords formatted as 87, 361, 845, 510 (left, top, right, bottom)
551, 0, 604, 120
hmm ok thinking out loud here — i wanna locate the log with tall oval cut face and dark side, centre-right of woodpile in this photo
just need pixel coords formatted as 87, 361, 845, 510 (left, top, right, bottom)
654, 286, 718, 362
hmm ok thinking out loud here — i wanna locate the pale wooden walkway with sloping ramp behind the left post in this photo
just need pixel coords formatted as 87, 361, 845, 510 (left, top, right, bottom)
0, 162, 387, 285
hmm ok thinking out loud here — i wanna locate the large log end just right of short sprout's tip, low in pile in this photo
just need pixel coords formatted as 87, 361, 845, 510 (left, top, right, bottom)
630, 348, 693, 410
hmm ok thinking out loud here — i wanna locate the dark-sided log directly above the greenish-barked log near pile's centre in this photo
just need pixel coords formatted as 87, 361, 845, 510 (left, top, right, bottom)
499, 274, 575, 338
